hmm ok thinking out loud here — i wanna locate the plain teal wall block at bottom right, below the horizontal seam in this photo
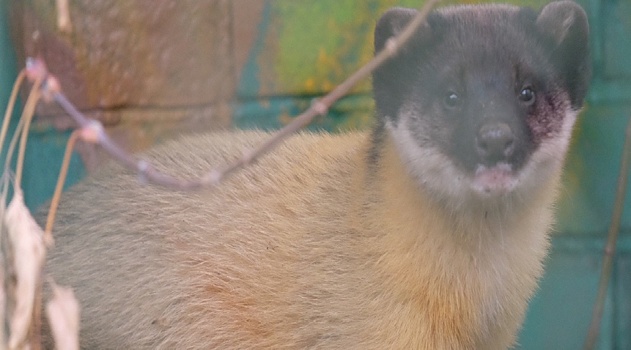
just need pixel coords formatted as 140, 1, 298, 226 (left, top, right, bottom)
518, 235, 628, 350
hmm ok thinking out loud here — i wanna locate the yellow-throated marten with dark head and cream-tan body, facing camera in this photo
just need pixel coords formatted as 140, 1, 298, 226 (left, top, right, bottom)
46, 1, 590, 350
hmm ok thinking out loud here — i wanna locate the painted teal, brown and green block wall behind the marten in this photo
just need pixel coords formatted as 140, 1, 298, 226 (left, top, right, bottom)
0, 0, 631, 349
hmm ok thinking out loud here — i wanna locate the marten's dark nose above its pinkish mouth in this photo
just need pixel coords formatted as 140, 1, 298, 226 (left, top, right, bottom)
476, 123, 515, 164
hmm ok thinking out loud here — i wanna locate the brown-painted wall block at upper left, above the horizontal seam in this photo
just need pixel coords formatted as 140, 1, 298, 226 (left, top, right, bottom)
12, 0, 235, 108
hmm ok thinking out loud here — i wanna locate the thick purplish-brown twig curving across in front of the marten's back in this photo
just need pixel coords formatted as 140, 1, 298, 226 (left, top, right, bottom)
33, 0, 440, 190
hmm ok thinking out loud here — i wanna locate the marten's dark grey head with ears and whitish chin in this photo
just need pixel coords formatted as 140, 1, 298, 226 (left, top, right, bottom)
373, 1, 590, 205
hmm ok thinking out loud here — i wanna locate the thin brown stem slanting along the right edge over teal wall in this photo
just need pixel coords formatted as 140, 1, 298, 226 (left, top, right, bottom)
584, 118, 631, 350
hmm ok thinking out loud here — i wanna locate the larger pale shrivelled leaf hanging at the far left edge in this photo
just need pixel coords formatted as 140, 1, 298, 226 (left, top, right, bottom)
4, 189, 46, 349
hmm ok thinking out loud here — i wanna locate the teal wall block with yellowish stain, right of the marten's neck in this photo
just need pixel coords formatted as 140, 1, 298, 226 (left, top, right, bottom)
556, 103, 631, 235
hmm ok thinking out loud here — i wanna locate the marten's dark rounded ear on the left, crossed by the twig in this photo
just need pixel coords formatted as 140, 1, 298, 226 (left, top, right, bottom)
375, 7, 430, 52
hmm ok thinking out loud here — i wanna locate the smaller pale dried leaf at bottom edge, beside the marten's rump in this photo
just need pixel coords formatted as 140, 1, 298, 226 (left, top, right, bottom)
46, 282, 80, 350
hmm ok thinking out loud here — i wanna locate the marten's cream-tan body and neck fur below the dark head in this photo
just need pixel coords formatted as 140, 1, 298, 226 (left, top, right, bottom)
47, 132, 562, 350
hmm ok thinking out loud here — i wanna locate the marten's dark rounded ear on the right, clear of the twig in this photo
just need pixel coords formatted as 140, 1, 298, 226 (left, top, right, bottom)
537, 0, 591, 109
